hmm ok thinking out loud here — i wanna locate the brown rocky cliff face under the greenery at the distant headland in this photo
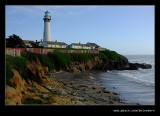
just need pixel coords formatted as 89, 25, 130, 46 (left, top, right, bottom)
67, 56, 128, 73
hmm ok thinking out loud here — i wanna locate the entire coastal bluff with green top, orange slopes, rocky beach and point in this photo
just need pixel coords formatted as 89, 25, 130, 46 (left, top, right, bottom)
5, 51, 150, 105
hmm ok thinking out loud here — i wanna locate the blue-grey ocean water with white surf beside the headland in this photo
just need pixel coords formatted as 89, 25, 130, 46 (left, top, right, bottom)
91, 55, 155, 105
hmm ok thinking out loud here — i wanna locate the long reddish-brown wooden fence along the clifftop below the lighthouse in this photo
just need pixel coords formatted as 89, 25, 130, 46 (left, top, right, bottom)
6, 48, 99, 56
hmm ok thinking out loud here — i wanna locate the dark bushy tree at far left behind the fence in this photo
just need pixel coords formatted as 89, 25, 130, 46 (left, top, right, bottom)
6, 34, 26, 48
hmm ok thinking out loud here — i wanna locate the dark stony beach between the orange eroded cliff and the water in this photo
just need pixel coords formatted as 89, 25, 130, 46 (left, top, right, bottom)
39, 72, 135, 105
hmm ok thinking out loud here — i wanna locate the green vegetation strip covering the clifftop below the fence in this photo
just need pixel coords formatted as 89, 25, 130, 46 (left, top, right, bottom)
6, 51, 125, 85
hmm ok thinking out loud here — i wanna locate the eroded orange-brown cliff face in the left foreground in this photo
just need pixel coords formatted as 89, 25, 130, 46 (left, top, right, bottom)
5, 60, 47, 105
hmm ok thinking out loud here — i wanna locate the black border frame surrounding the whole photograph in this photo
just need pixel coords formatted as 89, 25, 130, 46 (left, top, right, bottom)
0, 0, 160, 115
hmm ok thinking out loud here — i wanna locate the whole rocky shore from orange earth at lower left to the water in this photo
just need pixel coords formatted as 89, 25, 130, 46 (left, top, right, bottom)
6, 71, 137, 105
